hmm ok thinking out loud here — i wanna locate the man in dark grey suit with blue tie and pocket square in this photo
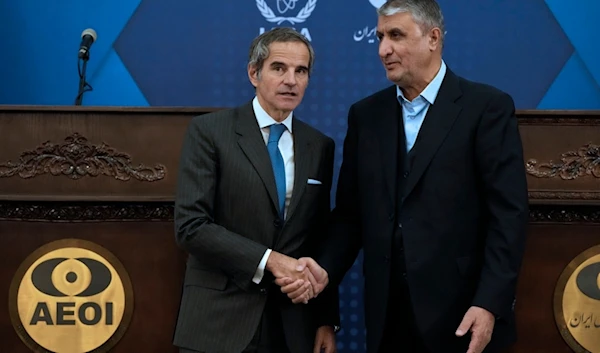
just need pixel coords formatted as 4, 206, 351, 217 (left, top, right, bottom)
174, 28, 339, 353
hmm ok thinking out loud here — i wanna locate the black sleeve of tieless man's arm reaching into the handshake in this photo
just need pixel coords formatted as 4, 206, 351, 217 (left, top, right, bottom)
317, 106, 362, 286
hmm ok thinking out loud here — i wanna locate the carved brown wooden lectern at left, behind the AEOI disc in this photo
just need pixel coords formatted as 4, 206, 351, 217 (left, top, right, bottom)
0, 107, 210, 353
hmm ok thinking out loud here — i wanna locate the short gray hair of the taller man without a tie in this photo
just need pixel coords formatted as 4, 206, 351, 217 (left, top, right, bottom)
377, 0, 446, 43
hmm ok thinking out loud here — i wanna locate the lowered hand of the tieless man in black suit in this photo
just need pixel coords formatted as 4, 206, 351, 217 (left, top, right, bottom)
456, 306, 496, 353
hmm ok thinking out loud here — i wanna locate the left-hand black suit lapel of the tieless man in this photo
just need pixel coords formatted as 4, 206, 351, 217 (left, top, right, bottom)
373, 86, 402, 210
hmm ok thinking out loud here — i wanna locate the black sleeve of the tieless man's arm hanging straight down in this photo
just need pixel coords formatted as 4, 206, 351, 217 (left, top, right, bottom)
473, 93, 529, 316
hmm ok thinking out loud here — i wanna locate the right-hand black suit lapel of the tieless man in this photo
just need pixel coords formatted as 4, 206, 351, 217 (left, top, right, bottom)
404, 69, 462, 197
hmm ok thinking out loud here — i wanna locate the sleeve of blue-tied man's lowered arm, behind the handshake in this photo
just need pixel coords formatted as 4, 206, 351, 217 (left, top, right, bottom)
308, 139, 340, 327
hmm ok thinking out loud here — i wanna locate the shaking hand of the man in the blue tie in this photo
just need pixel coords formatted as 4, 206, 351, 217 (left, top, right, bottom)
265, 251, 317, 304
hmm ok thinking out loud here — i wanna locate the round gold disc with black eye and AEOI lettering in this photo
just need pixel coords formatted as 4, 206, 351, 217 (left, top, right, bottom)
9, 239, 133, 353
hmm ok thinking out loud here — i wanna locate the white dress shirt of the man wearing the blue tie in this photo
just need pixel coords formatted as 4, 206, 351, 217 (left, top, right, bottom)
252, 97, 295, 284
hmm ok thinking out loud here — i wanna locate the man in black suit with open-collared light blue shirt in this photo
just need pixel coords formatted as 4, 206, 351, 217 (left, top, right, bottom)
283, 0, 528, 353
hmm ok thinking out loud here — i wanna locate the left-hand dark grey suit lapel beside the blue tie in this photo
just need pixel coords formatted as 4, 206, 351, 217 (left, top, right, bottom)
235, 103, 279, 211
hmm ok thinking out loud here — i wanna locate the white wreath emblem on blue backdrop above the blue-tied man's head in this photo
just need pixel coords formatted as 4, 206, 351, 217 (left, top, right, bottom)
256, 0, 317, 41
